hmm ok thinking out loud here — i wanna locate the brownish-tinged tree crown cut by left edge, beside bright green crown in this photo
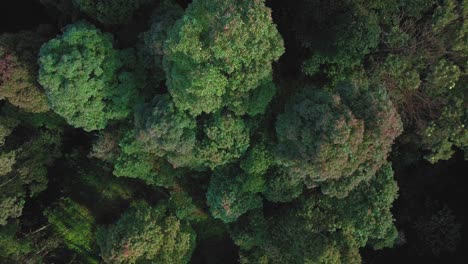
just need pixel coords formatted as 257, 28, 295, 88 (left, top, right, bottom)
0, 31, 49, 113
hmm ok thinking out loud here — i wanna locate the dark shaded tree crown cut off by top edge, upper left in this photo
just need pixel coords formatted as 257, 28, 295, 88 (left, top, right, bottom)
73, 0, 151, 25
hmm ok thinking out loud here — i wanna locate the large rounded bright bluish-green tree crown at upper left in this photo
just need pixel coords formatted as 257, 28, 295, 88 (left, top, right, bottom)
39, 22, 140, 131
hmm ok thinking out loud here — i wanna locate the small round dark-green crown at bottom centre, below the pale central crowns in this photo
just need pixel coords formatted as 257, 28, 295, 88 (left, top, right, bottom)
206, 167, 265, 223
